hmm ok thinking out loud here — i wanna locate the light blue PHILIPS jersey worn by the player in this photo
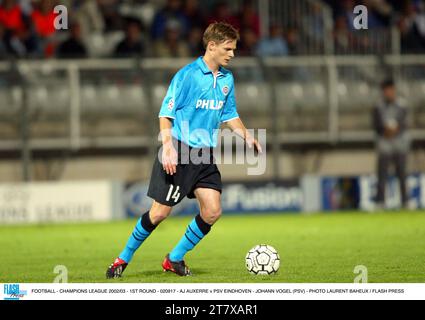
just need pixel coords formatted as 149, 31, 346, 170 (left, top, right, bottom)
159, 57, 239, 148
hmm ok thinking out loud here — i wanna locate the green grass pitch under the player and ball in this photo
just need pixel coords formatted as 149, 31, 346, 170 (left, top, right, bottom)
0, 212, 425, 283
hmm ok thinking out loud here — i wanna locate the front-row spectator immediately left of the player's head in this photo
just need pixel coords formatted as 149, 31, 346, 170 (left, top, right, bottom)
154, 20, 186, 58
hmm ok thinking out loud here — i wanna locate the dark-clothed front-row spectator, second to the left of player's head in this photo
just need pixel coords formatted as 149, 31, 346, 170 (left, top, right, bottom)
115, 19, 146, 58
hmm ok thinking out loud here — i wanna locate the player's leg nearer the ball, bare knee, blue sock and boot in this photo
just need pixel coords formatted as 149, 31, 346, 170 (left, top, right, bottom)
163, 188, 221, 275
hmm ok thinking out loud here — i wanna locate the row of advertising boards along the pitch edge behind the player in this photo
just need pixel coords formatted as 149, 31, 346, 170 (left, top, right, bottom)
0, 173, 425, 225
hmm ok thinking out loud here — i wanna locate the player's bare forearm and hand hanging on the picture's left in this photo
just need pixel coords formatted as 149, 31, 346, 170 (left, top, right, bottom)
159, 117, 177, 175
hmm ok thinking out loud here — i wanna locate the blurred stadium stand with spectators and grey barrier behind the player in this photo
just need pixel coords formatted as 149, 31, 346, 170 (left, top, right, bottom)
0, 0, 425, 182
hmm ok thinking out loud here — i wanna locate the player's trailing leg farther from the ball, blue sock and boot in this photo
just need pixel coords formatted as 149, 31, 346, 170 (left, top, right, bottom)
106, 201, 172, 279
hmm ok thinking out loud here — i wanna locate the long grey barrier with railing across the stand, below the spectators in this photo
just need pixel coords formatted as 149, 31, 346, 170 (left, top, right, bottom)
0, 55, 425, 179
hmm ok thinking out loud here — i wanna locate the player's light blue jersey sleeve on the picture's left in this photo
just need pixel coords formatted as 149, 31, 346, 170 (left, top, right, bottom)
159, 69, 187, 119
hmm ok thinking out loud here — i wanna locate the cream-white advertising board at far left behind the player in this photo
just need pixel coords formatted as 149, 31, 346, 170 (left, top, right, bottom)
0, 180, 124, 224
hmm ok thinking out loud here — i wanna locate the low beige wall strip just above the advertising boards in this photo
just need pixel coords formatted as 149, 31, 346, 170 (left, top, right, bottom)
0, 148, 425, 182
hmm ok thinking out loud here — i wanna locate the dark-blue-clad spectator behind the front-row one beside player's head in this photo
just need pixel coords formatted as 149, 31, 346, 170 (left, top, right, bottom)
152, 0, 189, 40
